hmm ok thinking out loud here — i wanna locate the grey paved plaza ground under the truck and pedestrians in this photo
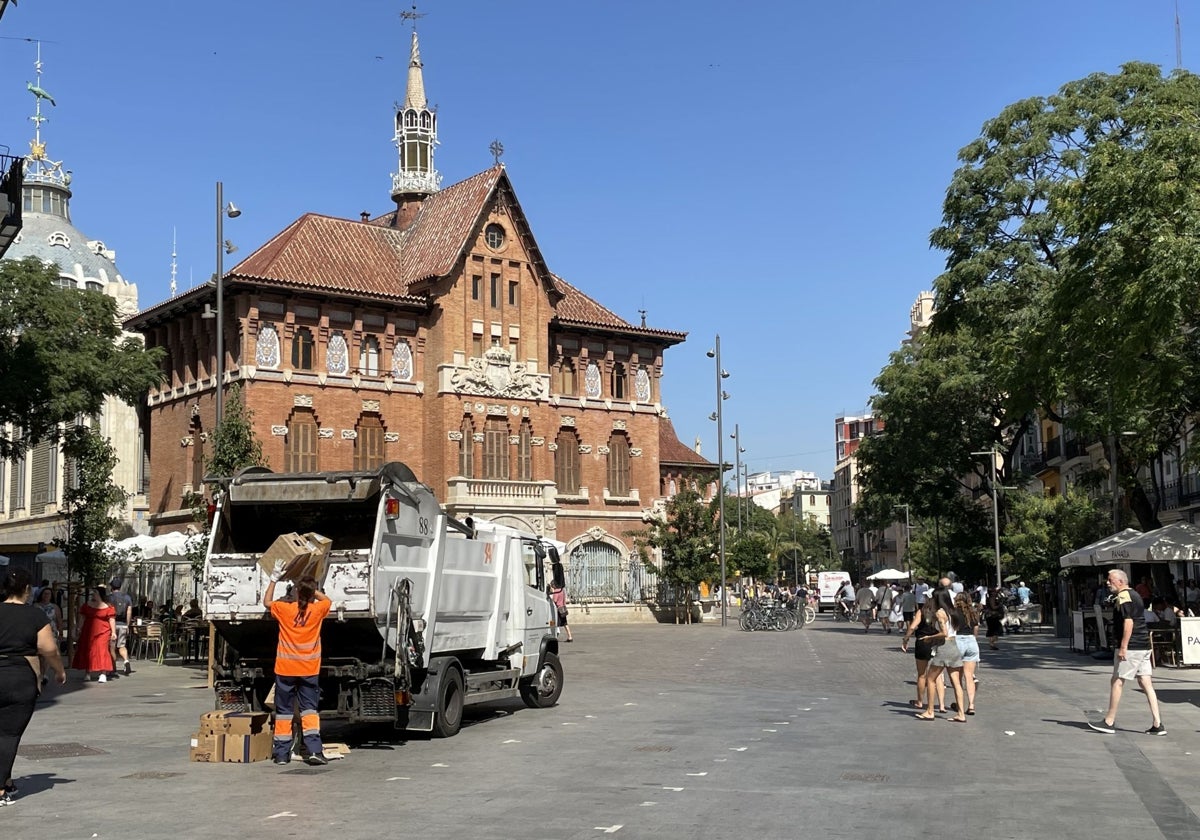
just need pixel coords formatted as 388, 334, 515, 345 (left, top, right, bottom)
0, 616, 1200, 840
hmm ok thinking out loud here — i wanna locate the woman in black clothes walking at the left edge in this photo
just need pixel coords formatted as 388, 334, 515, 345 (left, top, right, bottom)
0, 569, 67, 806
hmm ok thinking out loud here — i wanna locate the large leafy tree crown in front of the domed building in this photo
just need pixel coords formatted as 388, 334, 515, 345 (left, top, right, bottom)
0, 257, 162, 458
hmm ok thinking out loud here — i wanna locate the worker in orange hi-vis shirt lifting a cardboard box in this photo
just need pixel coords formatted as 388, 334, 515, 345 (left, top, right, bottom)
263, 573, 330, 766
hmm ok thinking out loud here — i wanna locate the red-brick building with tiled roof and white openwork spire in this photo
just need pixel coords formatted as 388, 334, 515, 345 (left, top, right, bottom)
127, 32, 716, 602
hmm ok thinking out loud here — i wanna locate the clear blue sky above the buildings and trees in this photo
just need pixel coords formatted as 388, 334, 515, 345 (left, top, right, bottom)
0, 0, 1180, 478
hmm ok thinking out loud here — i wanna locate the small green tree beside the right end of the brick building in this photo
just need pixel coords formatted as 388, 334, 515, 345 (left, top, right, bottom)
629, 488, 728, 622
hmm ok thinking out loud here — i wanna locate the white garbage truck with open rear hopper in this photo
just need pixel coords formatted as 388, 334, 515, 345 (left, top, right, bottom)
203, 462, 563, 737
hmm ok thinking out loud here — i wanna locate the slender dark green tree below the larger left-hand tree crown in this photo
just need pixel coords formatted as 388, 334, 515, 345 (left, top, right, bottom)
62, 425, 128, 587
